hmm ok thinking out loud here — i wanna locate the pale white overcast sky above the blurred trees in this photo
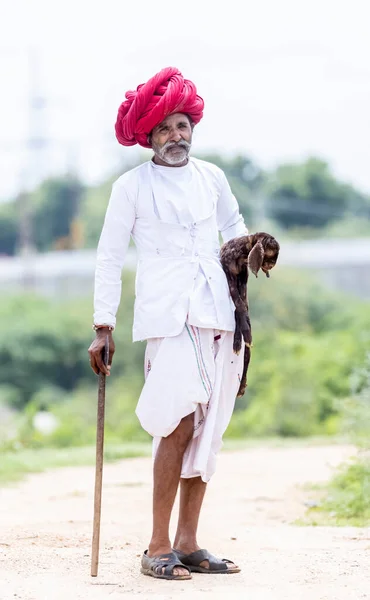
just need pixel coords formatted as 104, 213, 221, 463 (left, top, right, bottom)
0, 0, 370, 198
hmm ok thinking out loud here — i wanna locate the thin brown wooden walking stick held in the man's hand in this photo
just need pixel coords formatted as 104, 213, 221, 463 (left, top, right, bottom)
91, 336, 109, 577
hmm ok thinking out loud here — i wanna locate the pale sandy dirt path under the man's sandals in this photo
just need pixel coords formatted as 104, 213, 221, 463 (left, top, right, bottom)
0, 446, 370, 600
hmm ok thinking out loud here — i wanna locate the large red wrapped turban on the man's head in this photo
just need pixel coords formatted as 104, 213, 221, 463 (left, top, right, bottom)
115, 67, 204, 148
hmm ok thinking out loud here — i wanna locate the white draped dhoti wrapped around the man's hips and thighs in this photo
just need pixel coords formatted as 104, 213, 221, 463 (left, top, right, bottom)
136, 324, 243, 482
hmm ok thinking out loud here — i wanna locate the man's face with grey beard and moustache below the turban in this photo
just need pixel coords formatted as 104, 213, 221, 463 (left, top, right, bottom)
151, 113, 193, 166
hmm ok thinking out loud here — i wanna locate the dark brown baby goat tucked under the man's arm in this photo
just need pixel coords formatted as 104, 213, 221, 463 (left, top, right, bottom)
221, 232, 280, 398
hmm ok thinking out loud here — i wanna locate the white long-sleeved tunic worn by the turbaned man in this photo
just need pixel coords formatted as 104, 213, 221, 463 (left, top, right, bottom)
94, 158, 247, 341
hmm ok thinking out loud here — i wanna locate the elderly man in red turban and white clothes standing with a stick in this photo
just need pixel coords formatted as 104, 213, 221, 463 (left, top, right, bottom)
89, 67, 247, 579
